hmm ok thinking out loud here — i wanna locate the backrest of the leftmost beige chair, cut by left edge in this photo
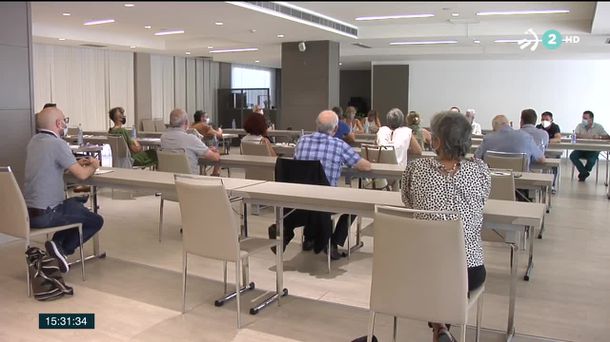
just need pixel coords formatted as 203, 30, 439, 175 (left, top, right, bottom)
0, 166, 30, 239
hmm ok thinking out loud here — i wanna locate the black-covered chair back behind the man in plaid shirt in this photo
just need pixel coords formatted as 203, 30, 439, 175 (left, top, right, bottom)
275, 158, 330, 186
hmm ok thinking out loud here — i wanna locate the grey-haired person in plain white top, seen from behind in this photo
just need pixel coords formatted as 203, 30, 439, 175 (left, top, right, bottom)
377, 108, 422, 167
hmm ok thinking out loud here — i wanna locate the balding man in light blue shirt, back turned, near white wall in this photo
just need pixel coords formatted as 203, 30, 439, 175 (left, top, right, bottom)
474, 115, 544, 169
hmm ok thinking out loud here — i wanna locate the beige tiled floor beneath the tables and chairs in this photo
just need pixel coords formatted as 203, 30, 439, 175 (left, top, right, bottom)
0, 159, 610, 342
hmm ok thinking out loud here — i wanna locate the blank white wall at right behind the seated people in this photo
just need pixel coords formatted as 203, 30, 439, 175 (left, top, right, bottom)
409, 60, 610, 132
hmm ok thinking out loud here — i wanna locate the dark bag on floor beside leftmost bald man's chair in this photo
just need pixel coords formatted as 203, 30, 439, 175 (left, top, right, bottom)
25, 247, 74, 301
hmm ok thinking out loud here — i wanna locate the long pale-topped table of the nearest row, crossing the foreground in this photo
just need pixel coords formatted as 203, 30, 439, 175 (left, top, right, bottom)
65, 168, 544, 338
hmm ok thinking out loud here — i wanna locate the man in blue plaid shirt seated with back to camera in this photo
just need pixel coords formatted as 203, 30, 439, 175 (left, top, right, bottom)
269, 110, 371, 260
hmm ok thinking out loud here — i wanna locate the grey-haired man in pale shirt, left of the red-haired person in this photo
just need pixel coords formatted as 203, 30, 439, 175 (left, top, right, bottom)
161, 108, 220, 176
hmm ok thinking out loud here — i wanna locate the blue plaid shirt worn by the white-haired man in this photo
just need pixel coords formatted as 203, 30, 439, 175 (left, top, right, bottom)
294, 132, 360, 186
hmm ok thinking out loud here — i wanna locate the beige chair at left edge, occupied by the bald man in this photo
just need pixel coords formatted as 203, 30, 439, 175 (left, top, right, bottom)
0, 166, 85, 297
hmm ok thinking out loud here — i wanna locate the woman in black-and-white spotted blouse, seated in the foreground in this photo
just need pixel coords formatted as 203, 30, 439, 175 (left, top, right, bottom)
401, 112, 491, 341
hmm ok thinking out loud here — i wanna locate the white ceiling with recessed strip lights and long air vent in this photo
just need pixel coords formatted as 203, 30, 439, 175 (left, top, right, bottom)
32, 2, 610, 69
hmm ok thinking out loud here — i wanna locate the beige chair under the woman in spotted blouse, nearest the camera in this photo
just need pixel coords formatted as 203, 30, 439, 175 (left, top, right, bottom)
368, 206, 485, 342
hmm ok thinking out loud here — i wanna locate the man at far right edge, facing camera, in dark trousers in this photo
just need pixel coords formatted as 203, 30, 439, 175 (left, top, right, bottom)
570, 110, 610, 182
